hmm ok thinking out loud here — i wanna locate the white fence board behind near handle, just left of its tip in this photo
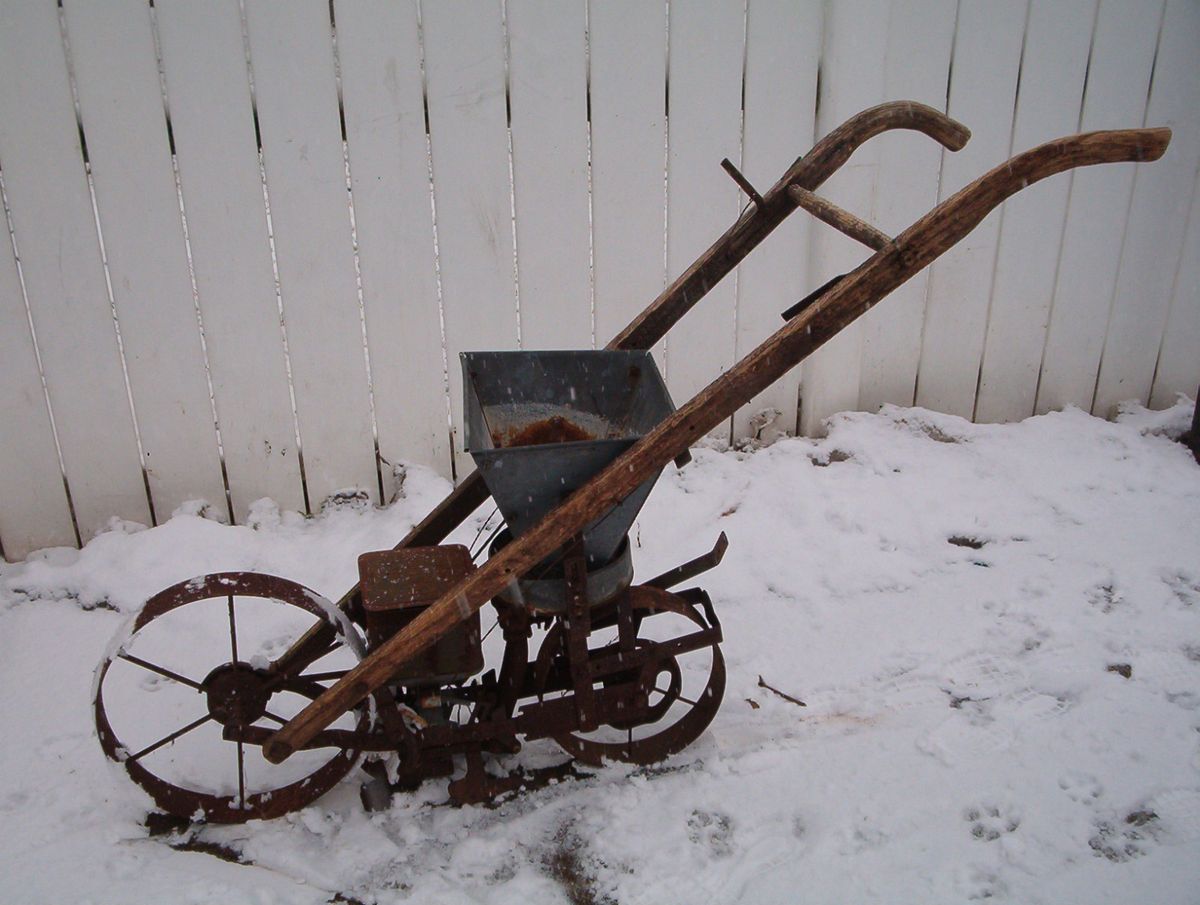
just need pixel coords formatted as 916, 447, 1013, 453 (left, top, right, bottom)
1037, 0, 1162, 412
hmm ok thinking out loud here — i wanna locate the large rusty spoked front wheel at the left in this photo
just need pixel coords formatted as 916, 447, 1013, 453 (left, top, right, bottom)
92, 573, 370, 823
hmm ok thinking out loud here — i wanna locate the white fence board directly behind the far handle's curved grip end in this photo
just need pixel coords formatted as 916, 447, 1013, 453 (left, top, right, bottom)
858, 0, 956, 412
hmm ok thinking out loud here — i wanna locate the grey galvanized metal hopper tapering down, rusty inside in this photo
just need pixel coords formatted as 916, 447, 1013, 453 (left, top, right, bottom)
462, 350, 674, 565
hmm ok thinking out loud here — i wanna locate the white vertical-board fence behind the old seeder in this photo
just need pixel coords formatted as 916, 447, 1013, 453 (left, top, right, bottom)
0, 0, 1200, 561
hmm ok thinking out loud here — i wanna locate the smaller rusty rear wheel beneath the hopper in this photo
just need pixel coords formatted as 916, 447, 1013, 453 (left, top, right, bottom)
535, 586, 725, 765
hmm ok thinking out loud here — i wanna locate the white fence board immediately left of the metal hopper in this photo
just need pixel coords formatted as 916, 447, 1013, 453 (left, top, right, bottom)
336, 0, 450, 497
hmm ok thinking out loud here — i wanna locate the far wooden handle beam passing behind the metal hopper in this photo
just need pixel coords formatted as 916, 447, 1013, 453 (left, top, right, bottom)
271, 101, 971, 675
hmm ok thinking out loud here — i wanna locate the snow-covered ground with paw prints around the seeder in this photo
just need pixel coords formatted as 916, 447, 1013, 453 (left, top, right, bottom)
0, 403, 1200, 905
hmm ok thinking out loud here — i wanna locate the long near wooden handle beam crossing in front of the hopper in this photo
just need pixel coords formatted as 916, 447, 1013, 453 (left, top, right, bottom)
264, 128, 1171, 763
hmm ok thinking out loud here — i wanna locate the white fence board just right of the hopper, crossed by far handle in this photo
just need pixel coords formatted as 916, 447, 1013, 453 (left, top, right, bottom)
666, 0, 745, 415
